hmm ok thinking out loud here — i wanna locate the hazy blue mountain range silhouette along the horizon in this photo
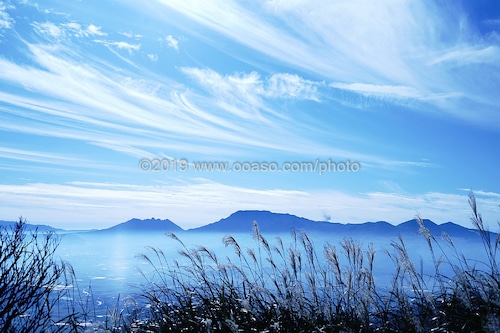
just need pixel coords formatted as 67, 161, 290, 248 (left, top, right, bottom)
0, 210, 484, 238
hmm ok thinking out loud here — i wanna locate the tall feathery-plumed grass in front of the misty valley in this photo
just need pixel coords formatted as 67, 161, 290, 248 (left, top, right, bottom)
0, 195, 500, 332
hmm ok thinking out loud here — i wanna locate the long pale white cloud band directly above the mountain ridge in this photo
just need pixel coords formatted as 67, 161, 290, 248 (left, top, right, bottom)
0, 179, 498, 230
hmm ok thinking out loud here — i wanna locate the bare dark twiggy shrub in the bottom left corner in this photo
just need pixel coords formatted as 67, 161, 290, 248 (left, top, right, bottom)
0, 218, 77, 333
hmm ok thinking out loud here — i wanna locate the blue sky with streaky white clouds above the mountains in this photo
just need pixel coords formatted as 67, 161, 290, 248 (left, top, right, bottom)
0, 0, 500, 231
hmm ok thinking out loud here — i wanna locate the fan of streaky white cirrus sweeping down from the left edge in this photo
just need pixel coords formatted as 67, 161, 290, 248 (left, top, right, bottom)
0, 44, 330, 155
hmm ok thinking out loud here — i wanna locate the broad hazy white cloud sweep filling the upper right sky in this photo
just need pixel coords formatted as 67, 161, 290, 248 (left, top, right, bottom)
153, 0, 500, 127
